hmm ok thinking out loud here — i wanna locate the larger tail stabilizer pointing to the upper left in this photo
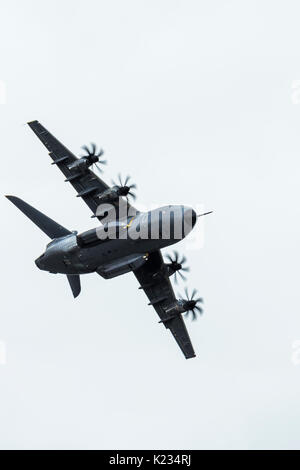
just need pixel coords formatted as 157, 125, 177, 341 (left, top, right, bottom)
6, 196, 72, 239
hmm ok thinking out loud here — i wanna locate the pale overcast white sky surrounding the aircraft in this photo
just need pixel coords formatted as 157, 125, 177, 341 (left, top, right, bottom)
0, 0, 300, 449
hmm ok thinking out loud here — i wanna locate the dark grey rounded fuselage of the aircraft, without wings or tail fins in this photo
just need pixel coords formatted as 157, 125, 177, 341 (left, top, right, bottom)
35, 206, 197, 277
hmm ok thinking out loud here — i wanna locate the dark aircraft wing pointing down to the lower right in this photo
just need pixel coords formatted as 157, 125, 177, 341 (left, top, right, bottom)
134, 251, 195, 359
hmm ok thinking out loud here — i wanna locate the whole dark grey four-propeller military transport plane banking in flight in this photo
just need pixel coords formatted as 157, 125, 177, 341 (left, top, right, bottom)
6, 121, 209, 359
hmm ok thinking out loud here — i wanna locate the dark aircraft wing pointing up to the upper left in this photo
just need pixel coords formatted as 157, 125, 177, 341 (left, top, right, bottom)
28, 121, 134, 222
